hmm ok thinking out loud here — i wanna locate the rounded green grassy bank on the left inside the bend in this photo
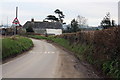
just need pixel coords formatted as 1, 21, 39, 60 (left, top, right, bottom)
1, 36, 33, 59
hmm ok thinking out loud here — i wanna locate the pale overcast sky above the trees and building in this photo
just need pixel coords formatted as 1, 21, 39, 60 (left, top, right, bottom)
0, 0, 119, 26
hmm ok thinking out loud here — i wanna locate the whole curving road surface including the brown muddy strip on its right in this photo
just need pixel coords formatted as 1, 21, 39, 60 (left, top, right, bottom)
2, 39, 97, 78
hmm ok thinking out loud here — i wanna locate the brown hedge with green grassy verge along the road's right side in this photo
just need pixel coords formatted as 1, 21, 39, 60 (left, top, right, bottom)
29, 27, 120, 78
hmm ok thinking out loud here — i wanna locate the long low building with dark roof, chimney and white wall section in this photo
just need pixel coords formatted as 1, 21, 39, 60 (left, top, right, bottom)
23, 19, 62, 35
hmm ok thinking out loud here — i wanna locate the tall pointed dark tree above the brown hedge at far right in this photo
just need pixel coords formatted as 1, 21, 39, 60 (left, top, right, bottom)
101, 12, 111, 29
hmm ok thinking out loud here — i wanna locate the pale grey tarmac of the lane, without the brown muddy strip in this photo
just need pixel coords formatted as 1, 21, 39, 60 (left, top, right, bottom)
2, 39, 59, 78
